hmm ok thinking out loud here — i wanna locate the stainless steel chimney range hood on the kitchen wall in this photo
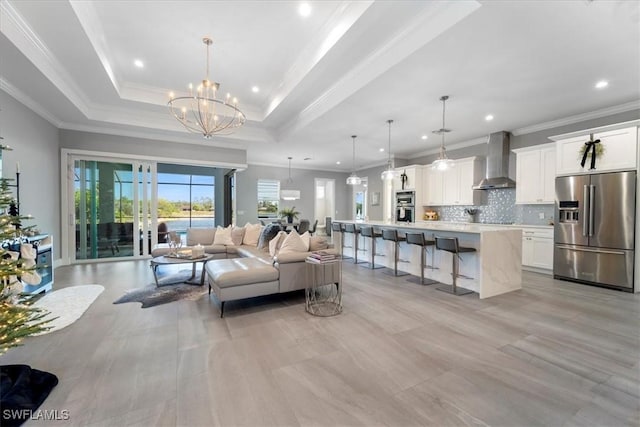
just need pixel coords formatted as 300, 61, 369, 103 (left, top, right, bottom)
473, 131, 516, 190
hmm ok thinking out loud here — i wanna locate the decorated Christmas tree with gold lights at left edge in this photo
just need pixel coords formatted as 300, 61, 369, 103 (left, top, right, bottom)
0, 178, 51, 355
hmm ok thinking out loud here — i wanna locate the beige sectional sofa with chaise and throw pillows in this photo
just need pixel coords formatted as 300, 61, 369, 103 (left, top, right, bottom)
151, 225, 340, 317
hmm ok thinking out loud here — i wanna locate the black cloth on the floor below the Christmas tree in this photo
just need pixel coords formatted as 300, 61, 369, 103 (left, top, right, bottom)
0, 365, 58, 426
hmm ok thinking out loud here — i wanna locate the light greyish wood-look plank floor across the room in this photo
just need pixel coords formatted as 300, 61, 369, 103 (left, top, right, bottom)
0, 261, 640, 426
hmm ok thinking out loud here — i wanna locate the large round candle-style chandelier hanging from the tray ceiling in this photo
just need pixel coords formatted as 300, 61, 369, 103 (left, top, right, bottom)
167, 37, 246, 139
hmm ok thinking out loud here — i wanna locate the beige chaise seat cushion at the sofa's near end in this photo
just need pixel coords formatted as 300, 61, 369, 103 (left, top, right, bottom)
205, 258, 279, 288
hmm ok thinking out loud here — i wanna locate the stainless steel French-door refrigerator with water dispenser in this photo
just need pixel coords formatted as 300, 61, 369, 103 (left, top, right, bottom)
553, 171, 636, 291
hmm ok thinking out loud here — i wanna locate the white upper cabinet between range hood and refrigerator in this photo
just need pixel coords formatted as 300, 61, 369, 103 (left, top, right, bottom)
513, 143, 556, 204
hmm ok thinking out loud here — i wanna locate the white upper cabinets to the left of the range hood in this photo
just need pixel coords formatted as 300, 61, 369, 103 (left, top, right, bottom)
422, 157, 483, 206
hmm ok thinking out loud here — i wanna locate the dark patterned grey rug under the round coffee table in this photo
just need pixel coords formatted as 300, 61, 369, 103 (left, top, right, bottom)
113, 283, 209, 308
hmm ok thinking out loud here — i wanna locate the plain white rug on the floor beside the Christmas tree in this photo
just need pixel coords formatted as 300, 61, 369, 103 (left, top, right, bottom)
33, 285, 104, 335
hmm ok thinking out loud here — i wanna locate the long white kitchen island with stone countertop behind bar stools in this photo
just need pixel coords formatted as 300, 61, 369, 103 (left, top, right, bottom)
334, 220, 522, 299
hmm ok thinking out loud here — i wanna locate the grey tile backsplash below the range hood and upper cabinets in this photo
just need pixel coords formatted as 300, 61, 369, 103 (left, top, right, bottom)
434, 188, 554, 225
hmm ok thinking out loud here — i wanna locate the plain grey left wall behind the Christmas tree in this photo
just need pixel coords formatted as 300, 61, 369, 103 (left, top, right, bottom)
0, 90, 60, 260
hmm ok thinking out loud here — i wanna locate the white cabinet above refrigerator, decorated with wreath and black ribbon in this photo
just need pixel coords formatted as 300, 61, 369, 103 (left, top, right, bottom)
553, 126, 638, 175
